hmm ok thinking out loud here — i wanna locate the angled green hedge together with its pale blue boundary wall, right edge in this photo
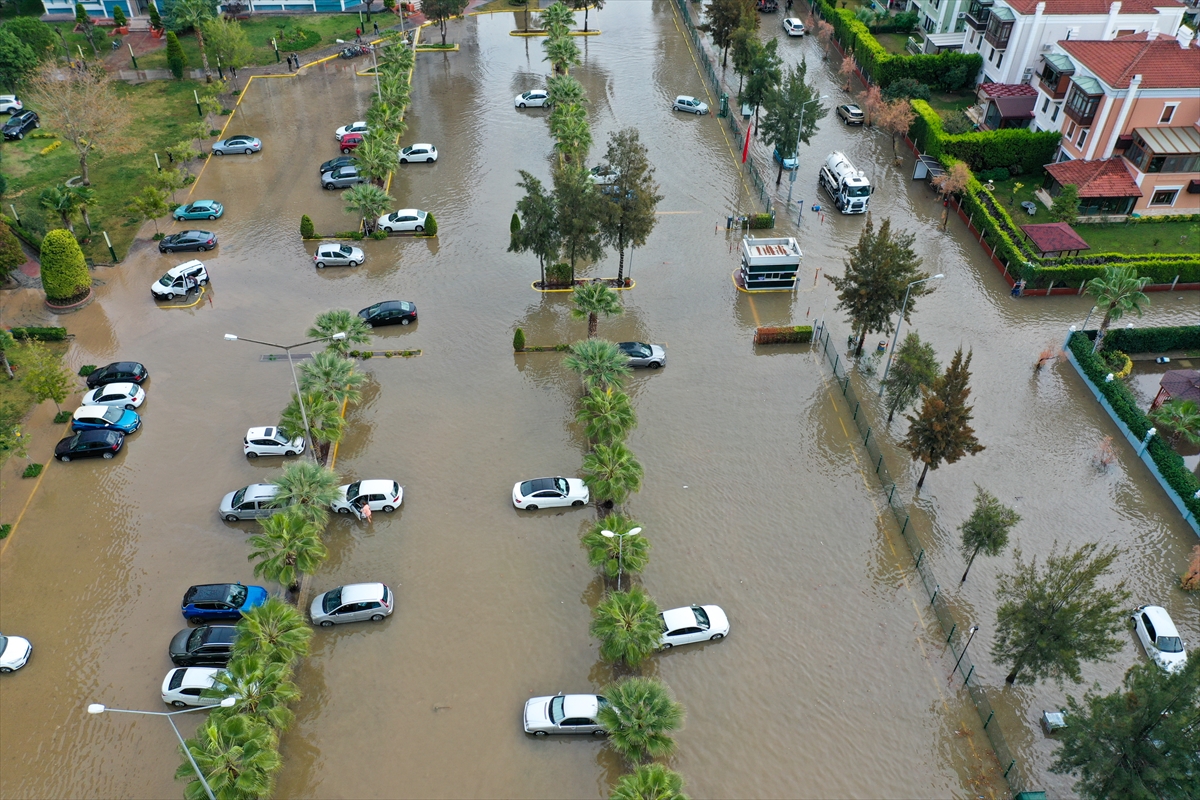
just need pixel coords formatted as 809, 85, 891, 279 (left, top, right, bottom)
1064, 325, 1200, 534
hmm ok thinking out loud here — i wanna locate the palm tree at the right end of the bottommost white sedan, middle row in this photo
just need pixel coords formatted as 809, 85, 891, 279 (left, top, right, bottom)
600, 678, 683, 762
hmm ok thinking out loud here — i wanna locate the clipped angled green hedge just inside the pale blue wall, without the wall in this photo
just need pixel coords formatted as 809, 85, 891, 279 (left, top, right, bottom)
1067, 326, 1200, 517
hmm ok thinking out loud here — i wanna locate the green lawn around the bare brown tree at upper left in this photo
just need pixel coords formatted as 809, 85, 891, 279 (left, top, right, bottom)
2, 80, 212, 261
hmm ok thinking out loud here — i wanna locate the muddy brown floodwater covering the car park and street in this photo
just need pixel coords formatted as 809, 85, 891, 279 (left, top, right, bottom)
0, 1, 1200, 798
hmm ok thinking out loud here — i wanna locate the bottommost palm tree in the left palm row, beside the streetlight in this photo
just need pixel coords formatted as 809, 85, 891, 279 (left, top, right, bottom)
175, 714, 283, 800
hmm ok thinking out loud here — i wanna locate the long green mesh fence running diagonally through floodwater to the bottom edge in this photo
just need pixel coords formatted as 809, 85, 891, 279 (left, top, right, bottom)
812, 325, 1033, 796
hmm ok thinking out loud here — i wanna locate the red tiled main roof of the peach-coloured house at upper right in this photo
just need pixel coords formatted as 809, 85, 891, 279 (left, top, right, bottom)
1058, 34, 1200, 89
